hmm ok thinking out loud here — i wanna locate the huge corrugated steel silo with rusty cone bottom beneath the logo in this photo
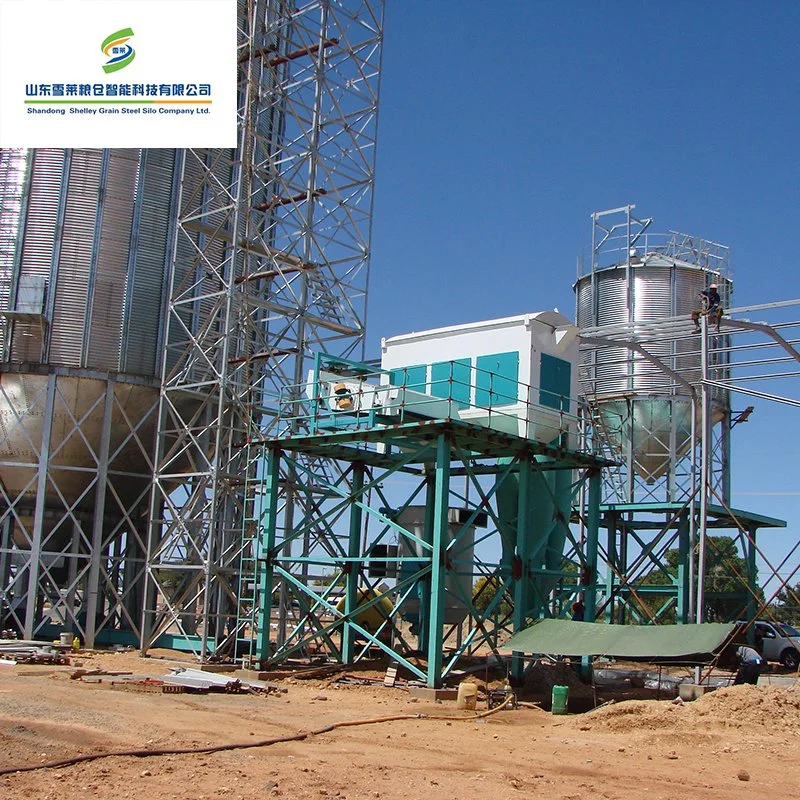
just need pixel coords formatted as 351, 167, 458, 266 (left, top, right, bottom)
0, 149, 231, 644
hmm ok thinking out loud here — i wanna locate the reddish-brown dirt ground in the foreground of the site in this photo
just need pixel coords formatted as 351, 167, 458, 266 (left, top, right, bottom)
0, 653, 800, 800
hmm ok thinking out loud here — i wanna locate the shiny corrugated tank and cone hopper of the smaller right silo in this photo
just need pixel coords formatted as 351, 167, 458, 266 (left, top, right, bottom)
574, 220, 733, 499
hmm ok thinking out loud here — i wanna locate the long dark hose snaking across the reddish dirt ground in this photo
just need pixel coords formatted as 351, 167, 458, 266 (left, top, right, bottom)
0, 695, 513, 775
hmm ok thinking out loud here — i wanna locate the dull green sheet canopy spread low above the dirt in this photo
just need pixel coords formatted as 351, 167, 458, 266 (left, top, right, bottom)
501, 619, 736, 661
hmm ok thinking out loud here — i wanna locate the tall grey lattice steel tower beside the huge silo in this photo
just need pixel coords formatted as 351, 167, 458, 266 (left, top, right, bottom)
142, 0, 383, 660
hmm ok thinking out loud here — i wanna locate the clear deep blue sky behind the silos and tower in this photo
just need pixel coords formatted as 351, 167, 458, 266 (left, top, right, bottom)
368, 0, 800, 592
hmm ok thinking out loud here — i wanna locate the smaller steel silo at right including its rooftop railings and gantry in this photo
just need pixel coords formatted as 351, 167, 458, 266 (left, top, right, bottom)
574, 206, 733, 502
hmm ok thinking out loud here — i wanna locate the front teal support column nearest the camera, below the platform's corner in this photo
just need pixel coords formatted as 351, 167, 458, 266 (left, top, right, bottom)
428, 433, 450, 689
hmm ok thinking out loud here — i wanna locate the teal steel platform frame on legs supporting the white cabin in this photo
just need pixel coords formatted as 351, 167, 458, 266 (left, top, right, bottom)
240, 357, 607, 687
